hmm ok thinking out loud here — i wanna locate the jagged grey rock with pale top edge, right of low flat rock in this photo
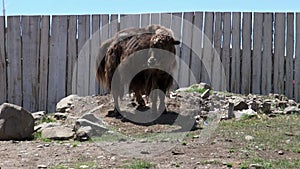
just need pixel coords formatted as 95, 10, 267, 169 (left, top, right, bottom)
74, 119, 108, 137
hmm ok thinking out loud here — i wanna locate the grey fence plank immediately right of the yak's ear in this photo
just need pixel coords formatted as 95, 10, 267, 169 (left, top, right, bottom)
179, 12, 194, 87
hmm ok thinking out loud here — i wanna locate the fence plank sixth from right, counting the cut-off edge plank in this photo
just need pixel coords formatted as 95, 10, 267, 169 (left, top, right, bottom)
241, 12, 252, 94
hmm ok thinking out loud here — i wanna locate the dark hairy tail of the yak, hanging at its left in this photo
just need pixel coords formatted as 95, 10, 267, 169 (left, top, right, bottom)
95, 39, 112, 88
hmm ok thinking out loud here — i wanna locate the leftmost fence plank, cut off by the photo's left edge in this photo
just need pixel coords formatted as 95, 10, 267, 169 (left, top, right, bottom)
0, 16, 7, 104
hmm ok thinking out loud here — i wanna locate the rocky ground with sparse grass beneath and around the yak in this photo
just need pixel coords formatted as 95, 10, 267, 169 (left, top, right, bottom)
0, 84, 300, 169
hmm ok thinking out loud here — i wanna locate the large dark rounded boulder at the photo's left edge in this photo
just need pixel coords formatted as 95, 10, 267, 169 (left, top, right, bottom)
0, 103, 34, 140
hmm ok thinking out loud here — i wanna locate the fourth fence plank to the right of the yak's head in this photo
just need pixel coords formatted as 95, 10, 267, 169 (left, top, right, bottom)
212, 12, 225, 90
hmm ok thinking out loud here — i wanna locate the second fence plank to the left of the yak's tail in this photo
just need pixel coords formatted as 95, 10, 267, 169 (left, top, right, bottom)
77, 15, 90, 96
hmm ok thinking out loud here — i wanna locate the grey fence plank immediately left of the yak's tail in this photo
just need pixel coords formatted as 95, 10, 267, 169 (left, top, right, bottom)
89, 15, 101, 95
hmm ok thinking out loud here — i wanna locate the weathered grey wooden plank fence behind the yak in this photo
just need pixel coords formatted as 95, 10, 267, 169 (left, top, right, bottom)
0, 12, 300, 112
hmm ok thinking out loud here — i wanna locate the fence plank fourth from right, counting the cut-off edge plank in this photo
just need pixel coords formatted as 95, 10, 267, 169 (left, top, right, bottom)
261, 13, 273, 95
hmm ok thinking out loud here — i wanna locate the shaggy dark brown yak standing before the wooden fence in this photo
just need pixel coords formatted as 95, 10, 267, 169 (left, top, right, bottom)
96, 25, 180, 112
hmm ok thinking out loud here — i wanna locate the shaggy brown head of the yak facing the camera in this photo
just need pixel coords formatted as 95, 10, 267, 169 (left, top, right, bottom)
147, 34, 180, 70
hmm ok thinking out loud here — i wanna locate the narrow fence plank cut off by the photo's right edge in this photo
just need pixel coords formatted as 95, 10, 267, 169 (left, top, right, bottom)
295, 13, 300, 102
